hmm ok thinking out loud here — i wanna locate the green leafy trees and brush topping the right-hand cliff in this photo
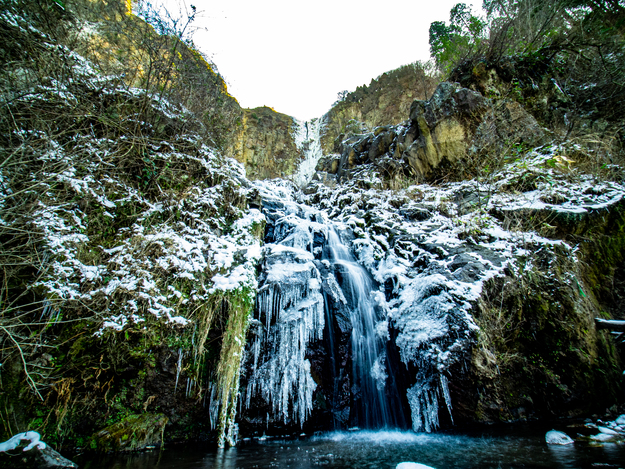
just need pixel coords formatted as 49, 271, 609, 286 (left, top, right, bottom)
430, 0, 625, 133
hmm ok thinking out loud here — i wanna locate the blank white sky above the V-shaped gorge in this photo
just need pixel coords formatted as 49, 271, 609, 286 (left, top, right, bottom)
153, 0, 464, 120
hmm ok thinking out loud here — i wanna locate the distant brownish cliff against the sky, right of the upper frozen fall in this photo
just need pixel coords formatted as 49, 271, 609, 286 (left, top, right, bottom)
321, 64, 438, 154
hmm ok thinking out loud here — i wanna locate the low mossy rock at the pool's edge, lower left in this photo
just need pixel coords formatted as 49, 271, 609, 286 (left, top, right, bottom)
87, 414, 169, 453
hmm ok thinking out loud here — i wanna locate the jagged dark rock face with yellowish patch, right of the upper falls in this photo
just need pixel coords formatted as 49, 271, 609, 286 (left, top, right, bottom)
318, 82, 545, 180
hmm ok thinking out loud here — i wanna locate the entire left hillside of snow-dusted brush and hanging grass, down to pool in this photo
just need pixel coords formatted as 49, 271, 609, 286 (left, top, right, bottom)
0, 0, 262, 448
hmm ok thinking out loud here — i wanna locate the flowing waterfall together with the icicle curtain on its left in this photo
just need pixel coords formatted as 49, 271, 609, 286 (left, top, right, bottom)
244, 182, 406, 428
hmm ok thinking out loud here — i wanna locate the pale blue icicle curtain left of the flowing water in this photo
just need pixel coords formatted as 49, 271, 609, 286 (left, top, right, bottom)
246, 181, 325, 424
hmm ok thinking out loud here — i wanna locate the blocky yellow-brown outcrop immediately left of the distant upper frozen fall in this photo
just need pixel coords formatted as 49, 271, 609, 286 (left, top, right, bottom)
227, 107, 301, 179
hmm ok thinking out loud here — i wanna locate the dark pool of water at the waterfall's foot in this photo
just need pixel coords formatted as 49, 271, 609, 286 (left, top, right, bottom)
74, 427, 625, 469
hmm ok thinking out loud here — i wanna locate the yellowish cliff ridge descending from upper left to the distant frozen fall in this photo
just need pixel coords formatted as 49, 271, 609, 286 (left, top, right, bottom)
71, 0, 300, 179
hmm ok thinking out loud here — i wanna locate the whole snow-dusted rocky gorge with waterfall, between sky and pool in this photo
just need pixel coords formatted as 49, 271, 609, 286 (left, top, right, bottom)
0, 0, 625, 464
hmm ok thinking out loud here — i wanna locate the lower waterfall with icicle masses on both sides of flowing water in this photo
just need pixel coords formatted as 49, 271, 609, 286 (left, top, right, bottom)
242, 182, 460, 431
